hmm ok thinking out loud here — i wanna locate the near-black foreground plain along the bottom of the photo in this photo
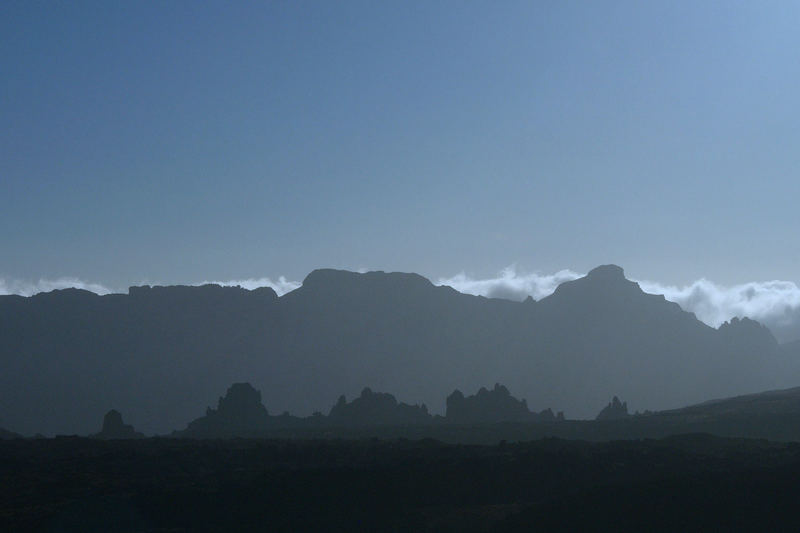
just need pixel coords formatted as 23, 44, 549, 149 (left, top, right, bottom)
0, 434, 800, 532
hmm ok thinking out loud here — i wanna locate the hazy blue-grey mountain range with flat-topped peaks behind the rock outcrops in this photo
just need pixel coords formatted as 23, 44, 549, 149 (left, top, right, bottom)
0, 266, 800, 434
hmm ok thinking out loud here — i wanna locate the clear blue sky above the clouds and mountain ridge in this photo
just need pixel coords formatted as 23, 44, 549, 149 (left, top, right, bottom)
0, 1, 800, 287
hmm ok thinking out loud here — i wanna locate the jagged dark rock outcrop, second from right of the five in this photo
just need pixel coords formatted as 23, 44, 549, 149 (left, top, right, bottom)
445, 383, 564, 424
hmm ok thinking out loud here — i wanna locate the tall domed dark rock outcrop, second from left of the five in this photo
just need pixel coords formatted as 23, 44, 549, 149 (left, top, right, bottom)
183, 383, 270, 437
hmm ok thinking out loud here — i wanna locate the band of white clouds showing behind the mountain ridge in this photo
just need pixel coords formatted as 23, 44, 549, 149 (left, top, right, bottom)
0, 266, 800, 342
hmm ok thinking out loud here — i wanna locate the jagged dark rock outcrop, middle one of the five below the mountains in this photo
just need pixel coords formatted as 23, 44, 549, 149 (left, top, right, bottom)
327, 387, 432, 426
